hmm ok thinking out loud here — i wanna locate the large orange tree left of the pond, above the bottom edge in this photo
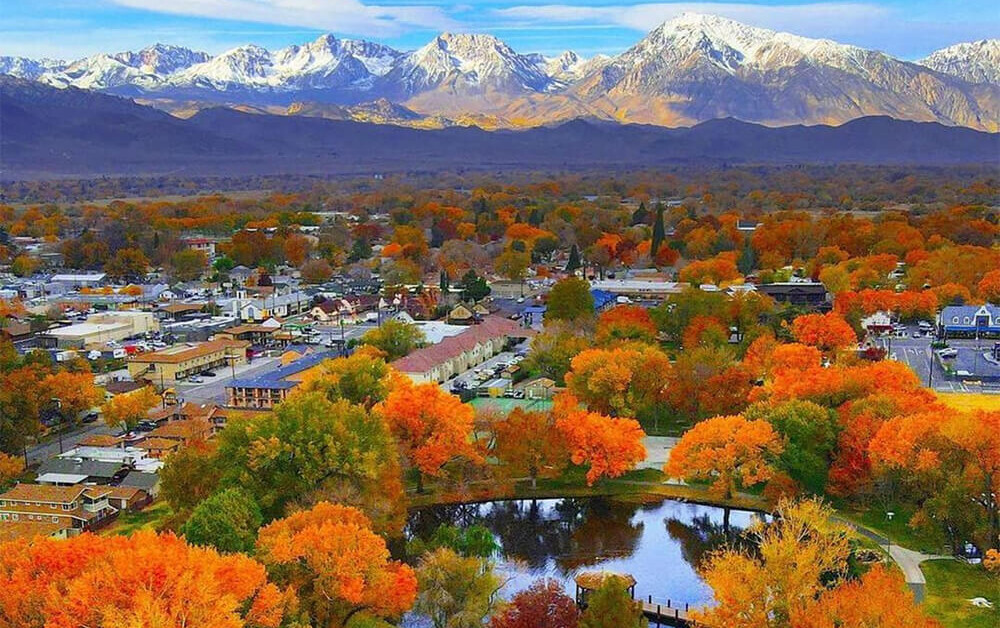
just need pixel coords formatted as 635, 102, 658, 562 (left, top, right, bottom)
257, 502, 417, 627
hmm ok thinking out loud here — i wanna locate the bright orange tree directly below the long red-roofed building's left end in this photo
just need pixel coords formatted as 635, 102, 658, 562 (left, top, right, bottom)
377, 381, 482, 491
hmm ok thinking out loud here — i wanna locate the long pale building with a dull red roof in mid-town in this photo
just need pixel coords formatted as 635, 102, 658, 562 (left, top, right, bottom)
392, 316, 530, 383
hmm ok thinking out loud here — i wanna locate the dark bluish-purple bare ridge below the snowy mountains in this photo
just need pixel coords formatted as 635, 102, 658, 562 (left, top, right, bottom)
0, 77, 1000, 180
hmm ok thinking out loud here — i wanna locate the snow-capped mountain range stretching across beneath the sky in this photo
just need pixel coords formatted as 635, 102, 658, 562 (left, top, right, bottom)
0, 13, 1000, 131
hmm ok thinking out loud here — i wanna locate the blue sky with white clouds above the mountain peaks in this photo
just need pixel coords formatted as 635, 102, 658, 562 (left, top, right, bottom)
0, 0, 1000, 59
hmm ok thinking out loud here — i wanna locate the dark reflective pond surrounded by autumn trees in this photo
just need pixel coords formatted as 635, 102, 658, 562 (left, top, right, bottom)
407, 497, 757, 606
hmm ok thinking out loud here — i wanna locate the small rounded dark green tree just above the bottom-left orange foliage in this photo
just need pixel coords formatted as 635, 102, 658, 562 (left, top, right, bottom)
181, 488, 264, 553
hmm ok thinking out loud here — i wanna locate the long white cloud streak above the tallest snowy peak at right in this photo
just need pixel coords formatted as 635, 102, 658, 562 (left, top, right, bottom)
494, 2, 890, 34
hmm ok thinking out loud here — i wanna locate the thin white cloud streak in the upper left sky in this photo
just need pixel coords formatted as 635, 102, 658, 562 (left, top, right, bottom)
106, 0, 456, 37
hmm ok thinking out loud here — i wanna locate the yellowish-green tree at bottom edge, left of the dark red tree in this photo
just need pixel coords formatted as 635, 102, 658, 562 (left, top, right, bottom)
413, 547, 502, 628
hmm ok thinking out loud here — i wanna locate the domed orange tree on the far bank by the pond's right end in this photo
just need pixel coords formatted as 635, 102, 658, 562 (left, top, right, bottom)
663, 415, 784, 499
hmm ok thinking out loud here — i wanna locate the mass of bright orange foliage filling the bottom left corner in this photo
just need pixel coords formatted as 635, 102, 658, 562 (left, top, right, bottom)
0, 531, 285, 628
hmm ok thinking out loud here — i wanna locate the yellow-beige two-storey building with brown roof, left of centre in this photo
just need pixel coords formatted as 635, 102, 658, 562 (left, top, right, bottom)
128, 340, 250, 390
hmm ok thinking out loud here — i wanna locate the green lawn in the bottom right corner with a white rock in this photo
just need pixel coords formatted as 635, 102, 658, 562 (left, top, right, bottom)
920, 560, 1000, 628
